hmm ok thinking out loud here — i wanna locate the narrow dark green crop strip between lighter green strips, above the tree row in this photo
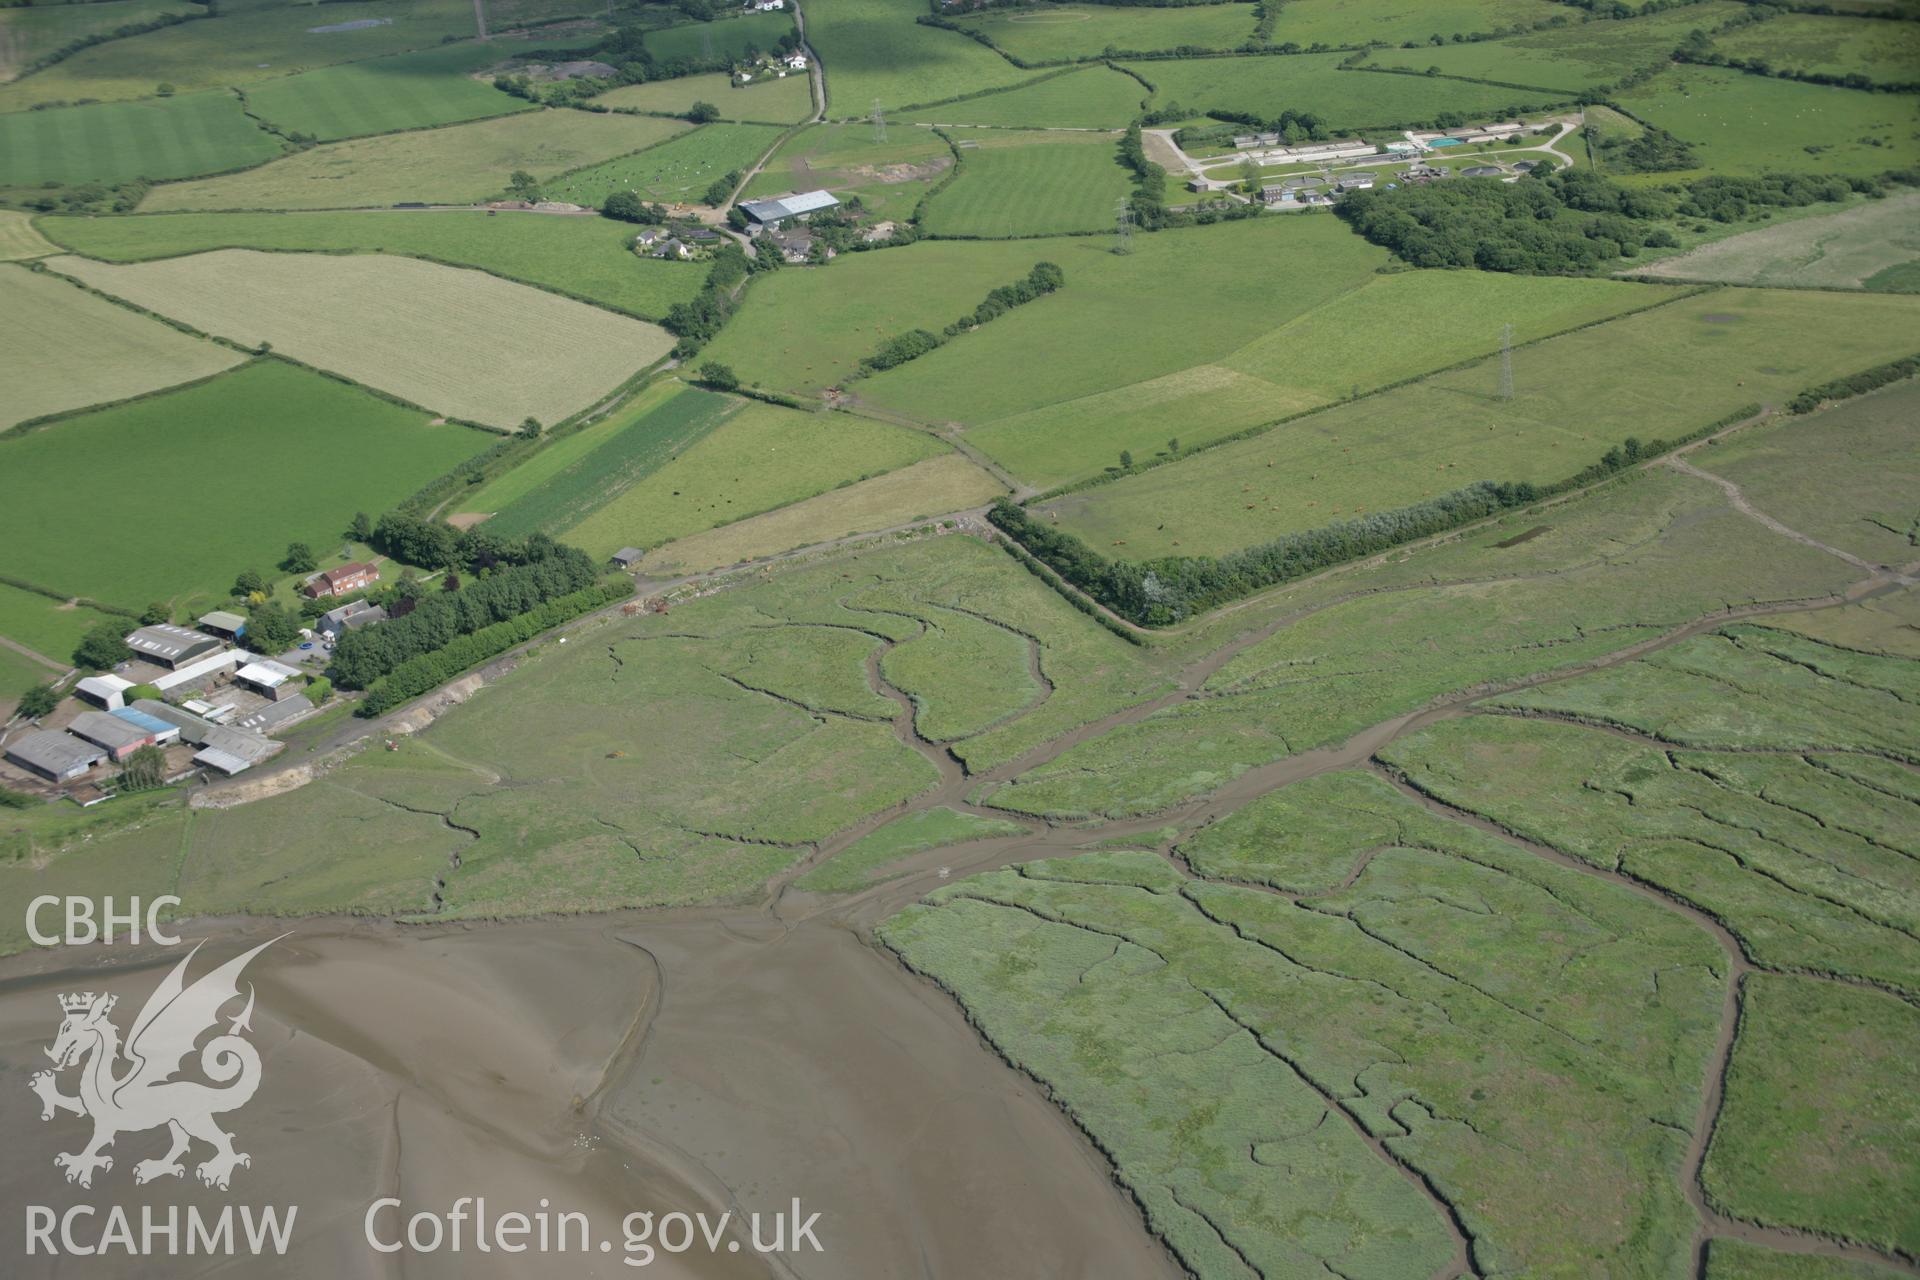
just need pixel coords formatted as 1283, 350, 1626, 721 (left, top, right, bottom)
476, 384, 741, 541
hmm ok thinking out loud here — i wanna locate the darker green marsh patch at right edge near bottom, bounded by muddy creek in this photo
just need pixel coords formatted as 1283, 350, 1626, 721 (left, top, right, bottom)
1701, 973, 1920, 1253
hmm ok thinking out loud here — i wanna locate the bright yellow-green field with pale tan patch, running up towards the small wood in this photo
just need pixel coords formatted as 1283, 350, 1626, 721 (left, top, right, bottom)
968, 271, 1661, 489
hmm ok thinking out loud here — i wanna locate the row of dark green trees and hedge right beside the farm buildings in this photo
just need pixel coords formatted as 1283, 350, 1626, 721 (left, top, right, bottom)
332, 543, 599, 689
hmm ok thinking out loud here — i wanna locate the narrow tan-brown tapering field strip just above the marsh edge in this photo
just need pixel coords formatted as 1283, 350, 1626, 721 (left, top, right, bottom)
641, 453, 1006, 574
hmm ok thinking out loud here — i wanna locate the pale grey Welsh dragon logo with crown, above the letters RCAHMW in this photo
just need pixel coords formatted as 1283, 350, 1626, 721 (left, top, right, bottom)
31, 935, 286, 1192
